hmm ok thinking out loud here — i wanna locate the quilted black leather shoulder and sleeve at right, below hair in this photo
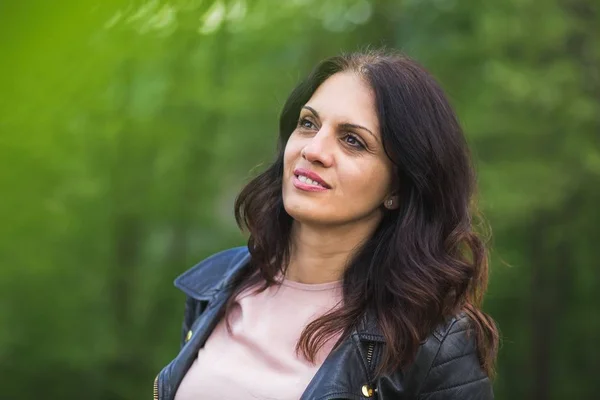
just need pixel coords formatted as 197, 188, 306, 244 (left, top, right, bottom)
417, 313, 494, 400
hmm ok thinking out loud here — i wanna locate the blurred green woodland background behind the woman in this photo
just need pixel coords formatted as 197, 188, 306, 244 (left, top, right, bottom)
0, 0, 600, 400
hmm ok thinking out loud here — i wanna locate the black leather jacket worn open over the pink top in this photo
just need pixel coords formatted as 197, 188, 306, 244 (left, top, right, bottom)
154, 247, 494, 400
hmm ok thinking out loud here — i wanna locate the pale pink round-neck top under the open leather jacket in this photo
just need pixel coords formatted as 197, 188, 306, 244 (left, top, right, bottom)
175, 280, 342, 400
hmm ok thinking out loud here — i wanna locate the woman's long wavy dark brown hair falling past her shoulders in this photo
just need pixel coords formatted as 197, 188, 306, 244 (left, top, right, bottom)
225, 50, 498, 376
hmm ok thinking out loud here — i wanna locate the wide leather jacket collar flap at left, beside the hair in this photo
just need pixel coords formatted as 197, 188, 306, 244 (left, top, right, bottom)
174, 246, 250, 300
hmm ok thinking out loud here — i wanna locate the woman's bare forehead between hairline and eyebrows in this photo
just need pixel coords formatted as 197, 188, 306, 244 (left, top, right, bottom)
306, 72, 379, 132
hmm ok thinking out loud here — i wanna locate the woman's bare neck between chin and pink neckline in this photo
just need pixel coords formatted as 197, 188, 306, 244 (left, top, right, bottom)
286, 221, 377, 284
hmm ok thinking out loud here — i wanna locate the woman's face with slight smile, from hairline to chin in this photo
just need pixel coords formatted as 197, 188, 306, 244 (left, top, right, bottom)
283, 72, 398, 225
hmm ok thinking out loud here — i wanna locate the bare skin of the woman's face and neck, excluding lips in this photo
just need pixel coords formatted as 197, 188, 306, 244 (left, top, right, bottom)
282, 72, 398, 283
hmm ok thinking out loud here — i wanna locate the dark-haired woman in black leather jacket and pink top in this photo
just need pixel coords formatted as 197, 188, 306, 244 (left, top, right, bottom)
155, 52, 498, 400
